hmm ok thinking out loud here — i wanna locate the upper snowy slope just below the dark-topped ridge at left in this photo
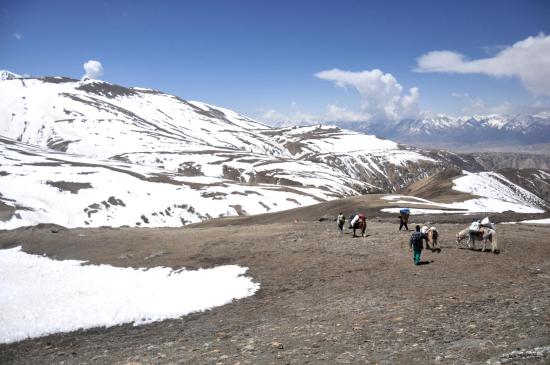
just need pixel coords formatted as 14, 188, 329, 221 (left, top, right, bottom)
0, 78, 285, 158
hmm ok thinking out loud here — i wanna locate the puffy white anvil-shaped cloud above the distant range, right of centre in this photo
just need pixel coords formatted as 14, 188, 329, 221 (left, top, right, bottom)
315, 68, 420, 120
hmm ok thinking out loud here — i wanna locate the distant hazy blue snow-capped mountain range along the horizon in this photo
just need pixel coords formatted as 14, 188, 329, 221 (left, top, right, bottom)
335, 113, 550, 147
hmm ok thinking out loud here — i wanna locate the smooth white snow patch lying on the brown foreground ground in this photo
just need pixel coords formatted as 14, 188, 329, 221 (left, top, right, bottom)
0, 247, 260, 343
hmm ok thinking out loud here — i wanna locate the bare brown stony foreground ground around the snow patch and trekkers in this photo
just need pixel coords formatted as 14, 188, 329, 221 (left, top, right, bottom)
0, 216, 550, 364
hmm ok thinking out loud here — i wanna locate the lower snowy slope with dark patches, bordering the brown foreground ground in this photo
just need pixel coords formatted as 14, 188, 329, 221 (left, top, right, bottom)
0, 138, 336, 229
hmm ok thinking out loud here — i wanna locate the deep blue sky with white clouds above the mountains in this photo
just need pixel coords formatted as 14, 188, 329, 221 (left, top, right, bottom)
0, 0, 550, 121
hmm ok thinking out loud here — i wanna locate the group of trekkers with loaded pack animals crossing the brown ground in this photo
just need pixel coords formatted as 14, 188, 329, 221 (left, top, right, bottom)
336, 208, 495, 265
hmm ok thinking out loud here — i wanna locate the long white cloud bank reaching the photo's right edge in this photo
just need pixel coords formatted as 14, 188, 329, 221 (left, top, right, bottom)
415, 33, 550, 95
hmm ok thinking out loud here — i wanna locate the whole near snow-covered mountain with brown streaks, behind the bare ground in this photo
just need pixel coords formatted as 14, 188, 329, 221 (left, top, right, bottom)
0, 72, 548, 228
